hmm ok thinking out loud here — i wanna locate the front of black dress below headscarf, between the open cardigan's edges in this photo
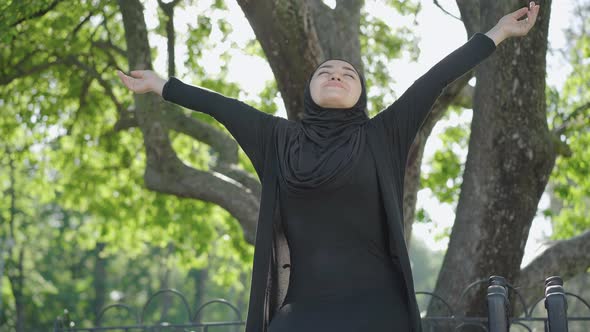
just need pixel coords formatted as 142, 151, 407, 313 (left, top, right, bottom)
269, 143, 409, 332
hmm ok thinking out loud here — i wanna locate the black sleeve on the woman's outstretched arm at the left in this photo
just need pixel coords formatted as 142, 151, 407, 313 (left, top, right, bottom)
162, 77, 282, 178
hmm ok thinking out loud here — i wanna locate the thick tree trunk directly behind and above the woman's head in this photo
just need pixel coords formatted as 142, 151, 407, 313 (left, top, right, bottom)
238, 0, 363, 120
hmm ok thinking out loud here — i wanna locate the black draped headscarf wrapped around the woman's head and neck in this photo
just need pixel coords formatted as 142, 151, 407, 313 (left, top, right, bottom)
277, 59, 369, 195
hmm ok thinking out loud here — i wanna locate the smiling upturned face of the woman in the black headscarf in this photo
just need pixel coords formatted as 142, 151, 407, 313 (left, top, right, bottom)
309, 60, 362, 108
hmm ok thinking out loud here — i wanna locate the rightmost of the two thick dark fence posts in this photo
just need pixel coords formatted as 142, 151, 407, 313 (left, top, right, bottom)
545, 276, 568, 332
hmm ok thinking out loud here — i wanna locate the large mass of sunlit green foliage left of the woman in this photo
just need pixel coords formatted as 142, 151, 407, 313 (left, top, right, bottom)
0, 1, 253, 330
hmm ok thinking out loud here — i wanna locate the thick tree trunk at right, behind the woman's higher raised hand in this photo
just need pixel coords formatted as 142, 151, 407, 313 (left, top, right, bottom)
429, 1, 555, 322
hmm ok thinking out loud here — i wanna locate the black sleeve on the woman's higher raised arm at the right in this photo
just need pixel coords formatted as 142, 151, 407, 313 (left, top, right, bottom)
371, 32, 496, 166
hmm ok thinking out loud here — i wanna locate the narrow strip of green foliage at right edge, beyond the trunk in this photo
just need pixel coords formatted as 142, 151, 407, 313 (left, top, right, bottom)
548, 1, 590, 238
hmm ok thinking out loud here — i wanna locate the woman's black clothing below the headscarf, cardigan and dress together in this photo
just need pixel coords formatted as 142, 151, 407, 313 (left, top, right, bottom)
162, 33, 496, 332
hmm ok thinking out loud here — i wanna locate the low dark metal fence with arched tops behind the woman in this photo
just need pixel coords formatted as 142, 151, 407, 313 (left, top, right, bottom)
53, 276, 590, 332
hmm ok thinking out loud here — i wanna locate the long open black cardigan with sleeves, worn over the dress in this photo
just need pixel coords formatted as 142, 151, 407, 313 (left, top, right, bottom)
162, 33, 496, 332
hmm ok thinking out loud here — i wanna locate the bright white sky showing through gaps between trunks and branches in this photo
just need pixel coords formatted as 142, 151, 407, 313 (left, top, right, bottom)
145, 0, 576, 265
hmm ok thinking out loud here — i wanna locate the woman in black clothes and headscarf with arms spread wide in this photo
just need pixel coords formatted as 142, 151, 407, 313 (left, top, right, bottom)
118, 2, 539, 332
